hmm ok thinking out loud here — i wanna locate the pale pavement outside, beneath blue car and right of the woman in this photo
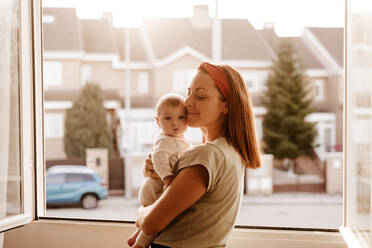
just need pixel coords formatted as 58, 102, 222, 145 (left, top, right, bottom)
46, 193, 343, 229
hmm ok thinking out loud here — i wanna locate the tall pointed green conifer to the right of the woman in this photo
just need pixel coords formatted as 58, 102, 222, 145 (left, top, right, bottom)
263, 39, 317, 159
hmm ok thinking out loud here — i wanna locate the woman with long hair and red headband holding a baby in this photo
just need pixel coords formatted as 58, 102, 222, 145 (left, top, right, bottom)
137, 62, 261, 248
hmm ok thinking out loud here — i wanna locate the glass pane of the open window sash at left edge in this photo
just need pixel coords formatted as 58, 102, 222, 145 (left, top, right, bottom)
0, 0, 23, 219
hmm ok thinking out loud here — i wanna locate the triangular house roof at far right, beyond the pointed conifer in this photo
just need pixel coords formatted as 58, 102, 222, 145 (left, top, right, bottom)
308, 27, 344, 67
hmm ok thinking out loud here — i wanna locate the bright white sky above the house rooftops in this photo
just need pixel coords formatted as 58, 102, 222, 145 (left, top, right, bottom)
43, 0, 348, 36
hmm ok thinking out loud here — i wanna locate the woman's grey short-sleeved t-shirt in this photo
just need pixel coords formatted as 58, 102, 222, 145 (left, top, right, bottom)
154, 138, 244, 248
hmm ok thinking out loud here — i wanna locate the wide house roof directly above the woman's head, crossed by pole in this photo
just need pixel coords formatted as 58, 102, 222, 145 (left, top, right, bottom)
144, 18, 271, 60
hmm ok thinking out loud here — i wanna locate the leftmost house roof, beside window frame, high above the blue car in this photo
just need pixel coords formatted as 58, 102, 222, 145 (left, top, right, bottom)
43, 8, 83, 51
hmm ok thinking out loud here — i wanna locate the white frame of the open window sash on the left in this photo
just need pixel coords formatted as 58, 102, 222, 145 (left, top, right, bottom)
0, 0, 35, 232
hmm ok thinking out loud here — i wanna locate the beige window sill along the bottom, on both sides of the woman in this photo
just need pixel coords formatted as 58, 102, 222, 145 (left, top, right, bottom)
4, 219, 347, 248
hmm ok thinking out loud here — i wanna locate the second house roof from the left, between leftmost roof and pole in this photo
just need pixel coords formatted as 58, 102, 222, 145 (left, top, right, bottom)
80, 18, 118, 53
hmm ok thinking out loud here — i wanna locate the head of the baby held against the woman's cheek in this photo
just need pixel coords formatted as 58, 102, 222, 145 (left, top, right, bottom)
155, 93, 187, 137
